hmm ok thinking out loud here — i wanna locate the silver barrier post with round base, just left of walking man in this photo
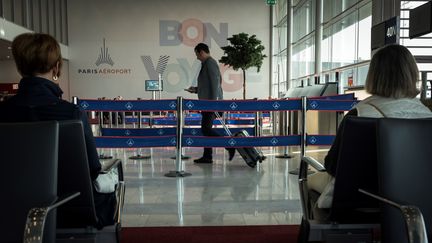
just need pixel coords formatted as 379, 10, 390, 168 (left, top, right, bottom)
165, 96, 192, 177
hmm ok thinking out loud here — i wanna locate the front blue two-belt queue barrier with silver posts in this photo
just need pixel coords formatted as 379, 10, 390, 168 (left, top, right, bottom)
74, 94, 357, 177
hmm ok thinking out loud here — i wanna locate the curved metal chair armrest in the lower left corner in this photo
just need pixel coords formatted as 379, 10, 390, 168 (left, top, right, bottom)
23, 192, 81, 243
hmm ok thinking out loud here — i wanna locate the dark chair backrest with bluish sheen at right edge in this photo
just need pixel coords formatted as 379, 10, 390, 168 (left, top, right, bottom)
377, 118, 432, 242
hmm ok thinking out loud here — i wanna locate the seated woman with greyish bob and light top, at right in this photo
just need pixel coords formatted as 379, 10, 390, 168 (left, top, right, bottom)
308, 45, 432, 208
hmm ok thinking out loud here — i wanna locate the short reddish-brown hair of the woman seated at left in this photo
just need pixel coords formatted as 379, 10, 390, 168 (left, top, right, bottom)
12, 33, 63, 76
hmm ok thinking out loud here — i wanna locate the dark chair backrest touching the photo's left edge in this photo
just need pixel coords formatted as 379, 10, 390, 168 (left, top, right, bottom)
0, 121, 58, 242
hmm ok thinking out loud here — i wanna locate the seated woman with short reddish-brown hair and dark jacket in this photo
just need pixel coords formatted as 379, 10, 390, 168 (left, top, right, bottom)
0, 33, 116, 227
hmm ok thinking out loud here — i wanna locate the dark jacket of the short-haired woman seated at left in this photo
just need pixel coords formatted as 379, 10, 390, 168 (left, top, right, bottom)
0, 77, 101, 180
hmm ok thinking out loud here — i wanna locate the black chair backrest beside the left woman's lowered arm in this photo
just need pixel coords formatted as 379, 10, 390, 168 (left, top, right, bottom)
57, 120, 98, 228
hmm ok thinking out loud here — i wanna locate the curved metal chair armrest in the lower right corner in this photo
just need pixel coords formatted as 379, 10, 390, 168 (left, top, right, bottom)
359, 189, 428, 243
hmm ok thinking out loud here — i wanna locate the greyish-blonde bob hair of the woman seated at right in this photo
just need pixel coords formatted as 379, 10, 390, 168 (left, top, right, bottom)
365, 44, 419, 99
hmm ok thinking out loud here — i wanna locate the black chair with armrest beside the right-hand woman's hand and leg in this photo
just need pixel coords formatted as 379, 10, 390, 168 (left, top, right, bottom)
298, 116, 379, 242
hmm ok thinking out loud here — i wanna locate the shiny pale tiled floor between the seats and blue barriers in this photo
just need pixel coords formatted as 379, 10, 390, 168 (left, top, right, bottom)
100, 145, 325, 227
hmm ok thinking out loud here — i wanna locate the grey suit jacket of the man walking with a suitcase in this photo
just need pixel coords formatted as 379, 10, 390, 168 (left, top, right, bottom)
197, 57, 223, 100
